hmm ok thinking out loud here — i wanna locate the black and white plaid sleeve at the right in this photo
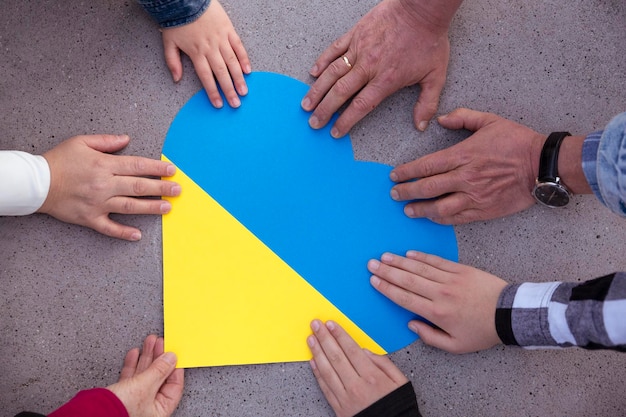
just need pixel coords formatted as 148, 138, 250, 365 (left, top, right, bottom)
496, 272, 626, 352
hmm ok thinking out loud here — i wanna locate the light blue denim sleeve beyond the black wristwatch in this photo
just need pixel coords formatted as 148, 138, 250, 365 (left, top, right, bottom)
582, 113, 626, 217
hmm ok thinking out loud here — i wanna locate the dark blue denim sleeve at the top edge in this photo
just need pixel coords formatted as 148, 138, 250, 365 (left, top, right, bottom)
137, 0, 211, 28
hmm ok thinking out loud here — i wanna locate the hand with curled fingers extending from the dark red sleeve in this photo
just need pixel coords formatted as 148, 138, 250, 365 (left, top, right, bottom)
107, 335, 185, 417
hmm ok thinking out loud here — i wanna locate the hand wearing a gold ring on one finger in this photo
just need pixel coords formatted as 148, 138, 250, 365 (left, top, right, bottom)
302, 0, 461, 138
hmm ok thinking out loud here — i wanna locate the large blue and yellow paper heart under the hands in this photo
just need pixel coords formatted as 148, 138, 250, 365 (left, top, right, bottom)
163, 73, 457, 367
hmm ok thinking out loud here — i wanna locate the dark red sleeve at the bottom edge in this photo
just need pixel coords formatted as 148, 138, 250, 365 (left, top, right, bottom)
48, 388, 129, 417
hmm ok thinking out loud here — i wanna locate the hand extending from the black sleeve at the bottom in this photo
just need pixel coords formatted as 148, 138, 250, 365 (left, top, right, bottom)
307, 320, 408, 417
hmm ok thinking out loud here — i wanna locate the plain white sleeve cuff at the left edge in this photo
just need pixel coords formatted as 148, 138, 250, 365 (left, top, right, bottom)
0, 151, 50, 216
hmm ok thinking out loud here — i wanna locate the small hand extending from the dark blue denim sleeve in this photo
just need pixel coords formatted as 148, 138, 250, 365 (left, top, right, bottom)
162, 0, 252, 108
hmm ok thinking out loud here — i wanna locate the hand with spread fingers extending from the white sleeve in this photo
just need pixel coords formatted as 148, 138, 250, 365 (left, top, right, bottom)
38, 135, 180, 241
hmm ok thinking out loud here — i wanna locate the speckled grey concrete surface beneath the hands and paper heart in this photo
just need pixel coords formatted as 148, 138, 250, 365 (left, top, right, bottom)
0, 0, 626, 417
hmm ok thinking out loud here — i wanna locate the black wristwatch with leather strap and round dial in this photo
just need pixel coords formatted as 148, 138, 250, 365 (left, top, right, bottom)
533, 132, 572, 208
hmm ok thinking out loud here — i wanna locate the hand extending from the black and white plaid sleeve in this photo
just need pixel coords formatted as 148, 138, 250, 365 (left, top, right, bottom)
367, 251, 507, 353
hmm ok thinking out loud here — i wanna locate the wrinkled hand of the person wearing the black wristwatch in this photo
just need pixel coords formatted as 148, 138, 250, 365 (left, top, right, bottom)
390, 109, 546, 224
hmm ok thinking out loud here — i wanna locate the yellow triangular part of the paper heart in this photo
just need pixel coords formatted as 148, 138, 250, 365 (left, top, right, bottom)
162, 156, 386, 368
